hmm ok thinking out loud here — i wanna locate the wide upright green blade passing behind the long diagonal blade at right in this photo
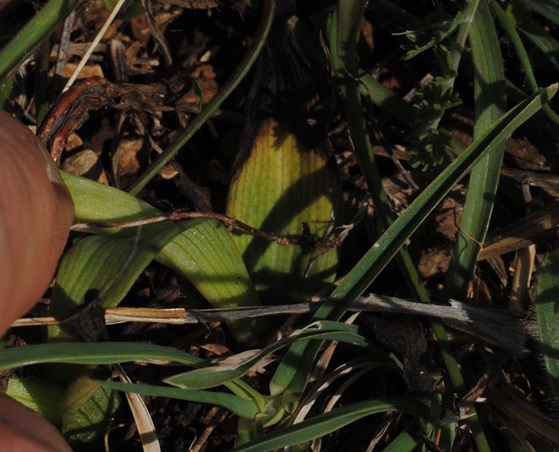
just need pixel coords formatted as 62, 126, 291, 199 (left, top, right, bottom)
444, 2, 506, 300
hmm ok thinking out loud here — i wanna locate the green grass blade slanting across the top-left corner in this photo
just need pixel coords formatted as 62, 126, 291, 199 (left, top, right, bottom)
0, 0, 80, 86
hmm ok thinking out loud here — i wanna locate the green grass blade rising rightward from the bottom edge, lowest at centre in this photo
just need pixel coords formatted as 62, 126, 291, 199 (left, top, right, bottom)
234, 397, 416, 452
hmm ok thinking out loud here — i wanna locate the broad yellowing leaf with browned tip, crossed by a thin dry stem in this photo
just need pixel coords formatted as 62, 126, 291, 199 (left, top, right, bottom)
227, 120, 340, 304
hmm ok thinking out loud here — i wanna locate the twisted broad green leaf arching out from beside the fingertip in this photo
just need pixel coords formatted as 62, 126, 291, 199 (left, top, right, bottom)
58, 173, 267, 345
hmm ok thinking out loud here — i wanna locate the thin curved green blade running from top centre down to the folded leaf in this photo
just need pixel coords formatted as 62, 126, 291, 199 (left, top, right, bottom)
128, 0, 275, 195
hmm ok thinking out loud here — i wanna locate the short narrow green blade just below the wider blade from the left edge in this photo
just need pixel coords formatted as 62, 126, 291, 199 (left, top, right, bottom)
96, 381, 258, 419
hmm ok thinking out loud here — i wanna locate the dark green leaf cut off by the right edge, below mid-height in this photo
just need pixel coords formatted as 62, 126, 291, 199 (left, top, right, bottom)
536, 250, 559, 400
